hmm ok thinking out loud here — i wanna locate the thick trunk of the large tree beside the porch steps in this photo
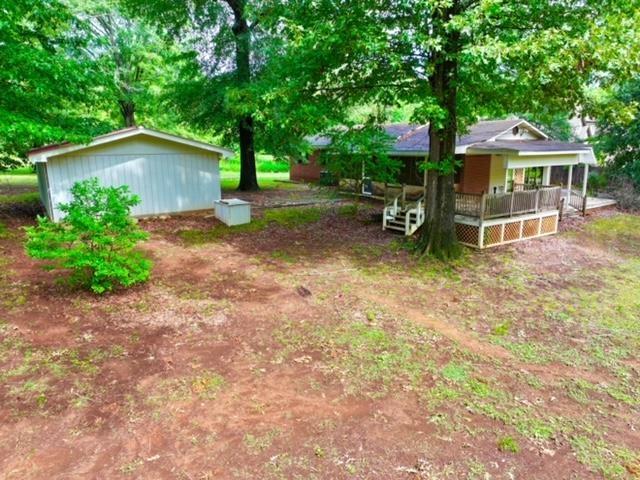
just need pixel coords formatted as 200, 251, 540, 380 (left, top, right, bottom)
419, 2, 460, 259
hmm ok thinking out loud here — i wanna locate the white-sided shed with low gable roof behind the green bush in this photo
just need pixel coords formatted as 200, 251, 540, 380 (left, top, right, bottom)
29, 127, 233, 221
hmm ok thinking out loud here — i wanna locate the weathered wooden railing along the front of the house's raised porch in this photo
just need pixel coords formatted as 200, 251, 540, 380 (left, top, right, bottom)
456, 187, 562, 220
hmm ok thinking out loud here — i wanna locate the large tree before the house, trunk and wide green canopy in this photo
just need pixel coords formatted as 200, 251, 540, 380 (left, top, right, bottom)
273, 0, 639, 258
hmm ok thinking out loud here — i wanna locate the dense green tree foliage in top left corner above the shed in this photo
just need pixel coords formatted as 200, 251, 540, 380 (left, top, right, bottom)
0, 0, 111, 168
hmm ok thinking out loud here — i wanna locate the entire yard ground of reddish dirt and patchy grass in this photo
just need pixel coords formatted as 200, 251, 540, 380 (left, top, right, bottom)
0, 187, 640, 480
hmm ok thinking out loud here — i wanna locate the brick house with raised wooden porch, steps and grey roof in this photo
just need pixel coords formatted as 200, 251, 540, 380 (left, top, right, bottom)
298, 119, 613, 248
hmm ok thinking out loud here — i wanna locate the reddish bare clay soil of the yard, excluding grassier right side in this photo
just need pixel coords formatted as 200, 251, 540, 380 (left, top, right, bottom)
0, 203, 636, 480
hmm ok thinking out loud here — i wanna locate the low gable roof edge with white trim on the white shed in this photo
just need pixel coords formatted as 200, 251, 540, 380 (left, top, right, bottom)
28, 126, 234, 163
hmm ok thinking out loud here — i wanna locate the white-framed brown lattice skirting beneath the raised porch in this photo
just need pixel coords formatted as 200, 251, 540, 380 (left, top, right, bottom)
456, 211, 558, 248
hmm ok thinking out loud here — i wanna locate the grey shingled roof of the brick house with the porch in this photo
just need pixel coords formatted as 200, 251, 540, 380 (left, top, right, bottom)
308, 118, 560, 155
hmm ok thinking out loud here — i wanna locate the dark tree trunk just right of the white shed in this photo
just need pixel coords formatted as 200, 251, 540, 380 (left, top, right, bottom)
227, 0, 259, 191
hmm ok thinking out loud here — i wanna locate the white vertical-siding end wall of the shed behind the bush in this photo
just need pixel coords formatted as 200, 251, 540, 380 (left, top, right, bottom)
47, 135, 220, 220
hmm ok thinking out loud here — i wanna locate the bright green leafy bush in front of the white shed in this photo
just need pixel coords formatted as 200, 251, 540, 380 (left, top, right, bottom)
26, 178, 152, 293
